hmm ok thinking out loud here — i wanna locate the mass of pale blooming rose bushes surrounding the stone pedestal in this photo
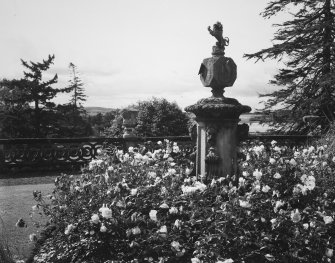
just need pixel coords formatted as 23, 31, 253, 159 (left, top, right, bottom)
28, 141, 335, 263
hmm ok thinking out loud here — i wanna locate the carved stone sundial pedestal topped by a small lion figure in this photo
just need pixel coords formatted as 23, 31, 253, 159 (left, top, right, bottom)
185, 22, 251, 181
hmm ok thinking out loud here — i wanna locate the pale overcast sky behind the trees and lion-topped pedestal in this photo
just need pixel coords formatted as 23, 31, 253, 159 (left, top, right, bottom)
0, 0, 288, 109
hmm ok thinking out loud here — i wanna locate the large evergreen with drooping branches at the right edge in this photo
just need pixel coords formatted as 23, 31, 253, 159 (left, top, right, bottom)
245, 0, 335, 132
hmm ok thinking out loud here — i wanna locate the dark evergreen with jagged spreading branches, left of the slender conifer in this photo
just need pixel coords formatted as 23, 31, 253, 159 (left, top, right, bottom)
21, 55, 68, 137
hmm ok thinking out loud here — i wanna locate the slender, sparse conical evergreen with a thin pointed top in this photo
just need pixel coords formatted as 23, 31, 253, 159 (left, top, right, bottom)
68, 63, 87, 110
